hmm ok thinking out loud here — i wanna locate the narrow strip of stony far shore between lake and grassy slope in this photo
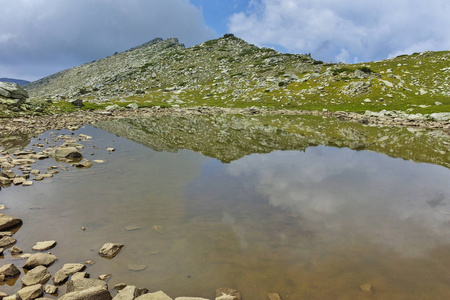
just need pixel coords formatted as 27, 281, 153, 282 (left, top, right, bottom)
0, 107, 450, 137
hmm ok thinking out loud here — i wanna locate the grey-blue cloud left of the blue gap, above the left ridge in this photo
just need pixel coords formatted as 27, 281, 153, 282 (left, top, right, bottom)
0, 0, 216, 79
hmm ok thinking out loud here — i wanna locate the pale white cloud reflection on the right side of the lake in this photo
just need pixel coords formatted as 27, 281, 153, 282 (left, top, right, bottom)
227, 147, 450, 255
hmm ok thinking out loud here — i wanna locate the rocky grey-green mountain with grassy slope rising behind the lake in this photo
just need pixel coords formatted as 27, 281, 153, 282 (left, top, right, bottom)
25, 34, 450, 114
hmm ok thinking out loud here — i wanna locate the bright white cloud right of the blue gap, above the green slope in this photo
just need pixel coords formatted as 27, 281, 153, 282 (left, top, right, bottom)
228, 0, 450, 62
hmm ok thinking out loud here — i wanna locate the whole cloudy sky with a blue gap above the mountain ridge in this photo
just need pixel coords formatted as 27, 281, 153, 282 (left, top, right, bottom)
0, 0, 450, 81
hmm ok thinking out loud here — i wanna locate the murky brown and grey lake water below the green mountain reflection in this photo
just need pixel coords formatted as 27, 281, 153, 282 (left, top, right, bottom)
0, 116, 450, 300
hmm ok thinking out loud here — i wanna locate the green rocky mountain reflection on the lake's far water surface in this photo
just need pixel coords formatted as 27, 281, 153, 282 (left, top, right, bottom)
97, 115, 450, 167
